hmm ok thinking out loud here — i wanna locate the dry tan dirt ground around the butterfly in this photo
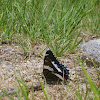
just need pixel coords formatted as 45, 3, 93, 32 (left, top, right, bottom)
0, 44, 100, 100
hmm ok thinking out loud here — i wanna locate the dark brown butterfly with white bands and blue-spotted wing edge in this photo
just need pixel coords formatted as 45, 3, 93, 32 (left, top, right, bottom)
43, 50, 69, 81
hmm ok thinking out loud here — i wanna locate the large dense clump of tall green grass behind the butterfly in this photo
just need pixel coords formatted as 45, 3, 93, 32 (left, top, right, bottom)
0, 0, 96, 56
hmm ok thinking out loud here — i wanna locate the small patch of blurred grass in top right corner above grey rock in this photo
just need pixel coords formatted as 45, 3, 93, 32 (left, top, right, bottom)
82, 0, 100, 35
